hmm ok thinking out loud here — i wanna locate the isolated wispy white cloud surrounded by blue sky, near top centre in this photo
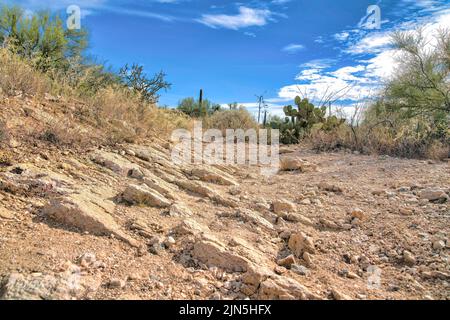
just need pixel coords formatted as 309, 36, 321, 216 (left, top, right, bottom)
197, 6, 272, 30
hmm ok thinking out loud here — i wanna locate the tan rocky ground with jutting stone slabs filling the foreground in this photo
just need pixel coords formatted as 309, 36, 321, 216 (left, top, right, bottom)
0, 94, 450, 299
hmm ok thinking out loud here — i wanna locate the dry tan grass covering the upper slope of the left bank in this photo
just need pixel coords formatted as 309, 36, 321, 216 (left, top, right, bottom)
0, 49, 191, 147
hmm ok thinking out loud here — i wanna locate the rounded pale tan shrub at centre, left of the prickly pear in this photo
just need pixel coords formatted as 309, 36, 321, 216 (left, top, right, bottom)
203, 108, 259, 134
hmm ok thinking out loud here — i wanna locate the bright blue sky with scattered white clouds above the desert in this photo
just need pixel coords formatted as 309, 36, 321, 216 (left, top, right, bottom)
4, 0, 450, 114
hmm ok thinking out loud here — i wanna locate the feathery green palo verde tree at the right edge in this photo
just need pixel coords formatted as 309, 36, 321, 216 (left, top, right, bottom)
384, 29, 450, 135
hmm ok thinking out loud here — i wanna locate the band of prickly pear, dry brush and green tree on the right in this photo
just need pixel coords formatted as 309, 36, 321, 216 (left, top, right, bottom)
268, 30, 450, 159
